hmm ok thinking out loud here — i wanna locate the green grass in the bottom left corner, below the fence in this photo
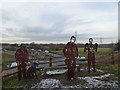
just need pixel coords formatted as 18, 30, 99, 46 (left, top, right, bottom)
2, 70, 42, 88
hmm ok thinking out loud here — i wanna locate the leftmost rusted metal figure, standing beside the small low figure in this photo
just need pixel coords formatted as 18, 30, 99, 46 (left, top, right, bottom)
15, 44, 29, 81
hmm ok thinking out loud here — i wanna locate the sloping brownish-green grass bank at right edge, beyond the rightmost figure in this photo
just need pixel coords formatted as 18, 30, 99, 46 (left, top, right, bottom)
96, 52, 120, 77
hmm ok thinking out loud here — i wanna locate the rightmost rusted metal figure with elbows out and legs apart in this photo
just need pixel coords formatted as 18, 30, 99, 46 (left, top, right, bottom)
84, 38, 98, 73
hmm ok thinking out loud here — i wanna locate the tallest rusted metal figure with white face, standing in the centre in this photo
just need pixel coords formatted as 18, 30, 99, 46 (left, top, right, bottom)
63, 36, 78, 80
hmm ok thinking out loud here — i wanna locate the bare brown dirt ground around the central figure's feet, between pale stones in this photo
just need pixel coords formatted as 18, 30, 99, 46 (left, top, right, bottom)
30, 70, 105, 86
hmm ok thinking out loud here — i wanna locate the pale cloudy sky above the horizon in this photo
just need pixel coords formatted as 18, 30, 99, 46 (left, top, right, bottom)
0, 1, 118, 43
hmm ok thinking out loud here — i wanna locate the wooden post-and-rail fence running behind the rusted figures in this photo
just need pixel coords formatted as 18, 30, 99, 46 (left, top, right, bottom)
2, 58, 80, 77
